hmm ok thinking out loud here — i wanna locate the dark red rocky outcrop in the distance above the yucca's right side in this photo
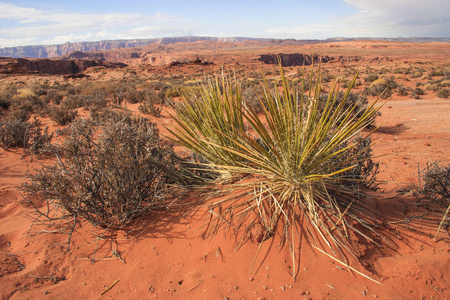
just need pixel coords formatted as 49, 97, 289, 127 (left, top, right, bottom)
258, 53, 362, 67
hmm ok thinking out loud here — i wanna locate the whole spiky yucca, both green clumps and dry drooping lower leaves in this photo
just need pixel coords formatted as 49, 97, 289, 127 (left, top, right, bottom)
171, 66, 379, 275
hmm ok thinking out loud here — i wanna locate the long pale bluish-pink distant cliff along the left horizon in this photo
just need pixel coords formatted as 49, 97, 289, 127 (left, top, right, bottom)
0, 36, 260, 58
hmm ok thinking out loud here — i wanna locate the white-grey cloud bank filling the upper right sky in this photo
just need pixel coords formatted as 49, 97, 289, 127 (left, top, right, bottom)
267, 0, 450, 38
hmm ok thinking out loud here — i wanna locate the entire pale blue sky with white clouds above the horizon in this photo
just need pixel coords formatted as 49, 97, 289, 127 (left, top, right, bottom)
0, 0, 450, 47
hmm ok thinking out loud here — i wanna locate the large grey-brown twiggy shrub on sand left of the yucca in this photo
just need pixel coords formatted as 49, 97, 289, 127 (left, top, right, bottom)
22, 117, 204, 228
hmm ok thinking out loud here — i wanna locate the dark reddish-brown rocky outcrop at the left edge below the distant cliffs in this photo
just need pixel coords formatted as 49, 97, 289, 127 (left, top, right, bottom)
0, 58, 126, 75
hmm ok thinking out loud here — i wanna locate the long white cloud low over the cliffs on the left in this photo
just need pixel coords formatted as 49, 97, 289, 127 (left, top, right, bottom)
0, 2, 197, 47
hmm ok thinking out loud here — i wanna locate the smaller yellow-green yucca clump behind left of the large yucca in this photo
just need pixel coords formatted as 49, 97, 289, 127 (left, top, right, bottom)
169, 77, 245, 166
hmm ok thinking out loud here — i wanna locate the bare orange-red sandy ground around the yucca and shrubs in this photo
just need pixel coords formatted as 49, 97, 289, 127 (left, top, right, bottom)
0, 41, 450, 299
